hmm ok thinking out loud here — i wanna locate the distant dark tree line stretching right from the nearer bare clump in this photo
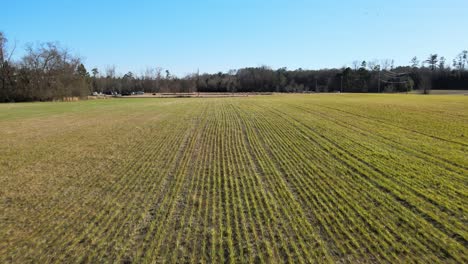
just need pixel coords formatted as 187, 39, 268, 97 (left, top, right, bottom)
85, 51, 468, 94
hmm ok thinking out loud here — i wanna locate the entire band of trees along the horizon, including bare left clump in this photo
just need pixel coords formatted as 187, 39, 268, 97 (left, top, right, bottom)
0, 32, 468, 102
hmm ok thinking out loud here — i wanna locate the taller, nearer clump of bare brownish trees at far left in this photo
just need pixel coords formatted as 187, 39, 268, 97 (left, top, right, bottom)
0, 32, 90, 102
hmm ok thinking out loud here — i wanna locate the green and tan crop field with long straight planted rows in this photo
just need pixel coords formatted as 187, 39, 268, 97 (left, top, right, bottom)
0, 94, 468, 263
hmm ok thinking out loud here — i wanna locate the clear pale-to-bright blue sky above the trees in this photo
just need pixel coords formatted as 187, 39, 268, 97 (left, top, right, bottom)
0, 0, 468, 75
